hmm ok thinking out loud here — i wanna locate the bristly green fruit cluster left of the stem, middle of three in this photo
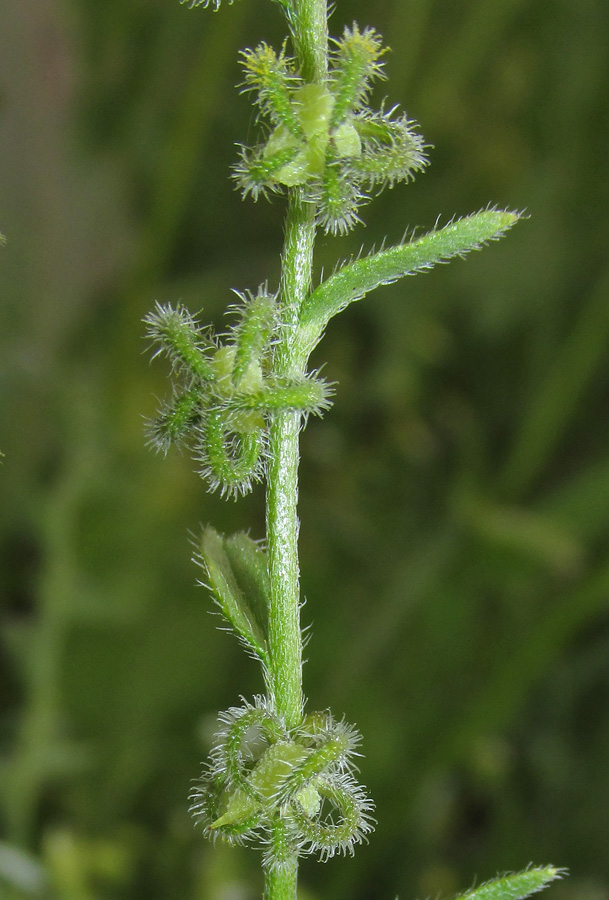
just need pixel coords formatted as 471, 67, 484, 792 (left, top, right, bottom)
145, 287, 331, 496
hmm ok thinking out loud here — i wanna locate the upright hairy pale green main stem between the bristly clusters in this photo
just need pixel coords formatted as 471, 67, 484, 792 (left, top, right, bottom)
264, 0, 328, 900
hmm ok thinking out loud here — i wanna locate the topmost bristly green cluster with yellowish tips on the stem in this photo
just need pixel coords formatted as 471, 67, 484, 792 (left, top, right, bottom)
235, 24, 427, 234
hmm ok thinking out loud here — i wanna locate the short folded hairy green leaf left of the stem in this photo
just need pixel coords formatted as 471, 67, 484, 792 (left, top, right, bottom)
201, 526, 267, 662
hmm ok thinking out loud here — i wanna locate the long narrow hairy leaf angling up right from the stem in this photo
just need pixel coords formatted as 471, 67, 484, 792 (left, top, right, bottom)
300, 209, 519, 351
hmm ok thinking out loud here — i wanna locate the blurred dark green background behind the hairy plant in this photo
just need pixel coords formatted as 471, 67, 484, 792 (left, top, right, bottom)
0, 0, 609, 900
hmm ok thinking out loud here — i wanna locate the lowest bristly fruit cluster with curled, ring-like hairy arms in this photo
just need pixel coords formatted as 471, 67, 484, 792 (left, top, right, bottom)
191, 697, 372, 868
